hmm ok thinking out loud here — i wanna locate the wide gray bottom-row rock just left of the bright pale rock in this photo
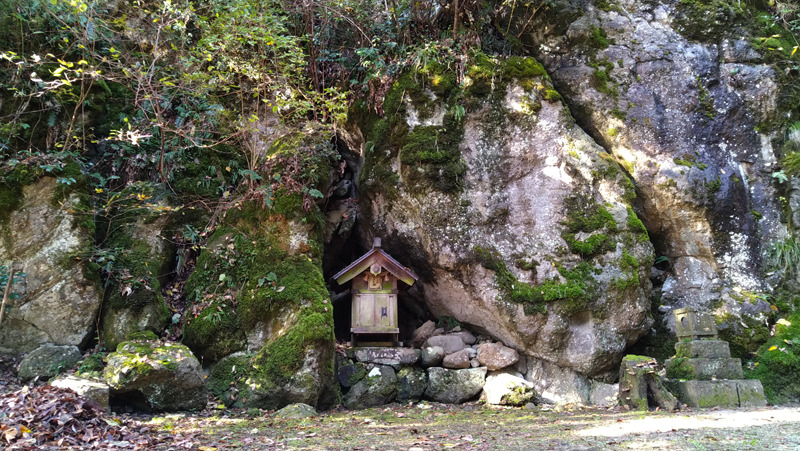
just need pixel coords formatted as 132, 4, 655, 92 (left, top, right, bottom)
425, 367, 486, 404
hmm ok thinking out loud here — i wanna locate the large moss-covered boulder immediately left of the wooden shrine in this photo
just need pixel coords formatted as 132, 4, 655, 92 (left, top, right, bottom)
192, 198, 337, 409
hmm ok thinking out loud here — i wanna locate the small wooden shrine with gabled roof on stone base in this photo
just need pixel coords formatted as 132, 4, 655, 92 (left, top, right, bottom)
333, 238, 417, 346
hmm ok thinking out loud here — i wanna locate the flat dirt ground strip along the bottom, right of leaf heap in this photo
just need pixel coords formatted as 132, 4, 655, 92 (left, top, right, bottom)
138, 402, 800, 451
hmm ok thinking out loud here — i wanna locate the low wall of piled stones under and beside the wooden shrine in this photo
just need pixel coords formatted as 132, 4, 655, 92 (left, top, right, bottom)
338, 322, 536, 408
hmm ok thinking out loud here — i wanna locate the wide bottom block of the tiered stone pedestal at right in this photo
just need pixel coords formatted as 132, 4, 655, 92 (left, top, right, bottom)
667, 379, 767, 407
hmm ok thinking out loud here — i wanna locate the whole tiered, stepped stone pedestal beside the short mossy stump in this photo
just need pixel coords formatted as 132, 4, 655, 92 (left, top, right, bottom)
665, 307, 766, 407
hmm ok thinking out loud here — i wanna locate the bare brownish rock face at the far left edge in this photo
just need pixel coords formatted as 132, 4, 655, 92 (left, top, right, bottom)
0, 177, 101, 352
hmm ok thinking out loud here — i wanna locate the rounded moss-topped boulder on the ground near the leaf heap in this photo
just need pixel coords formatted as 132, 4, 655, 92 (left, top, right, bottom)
103, 340, 207, 411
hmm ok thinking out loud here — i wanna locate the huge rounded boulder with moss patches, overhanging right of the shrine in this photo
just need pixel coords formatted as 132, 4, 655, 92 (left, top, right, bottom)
360, 57, 653, 377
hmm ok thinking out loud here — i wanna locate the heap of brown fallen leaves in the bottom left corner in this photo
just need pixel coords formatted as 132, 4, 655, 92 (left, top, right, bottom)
0, 385, 152, 449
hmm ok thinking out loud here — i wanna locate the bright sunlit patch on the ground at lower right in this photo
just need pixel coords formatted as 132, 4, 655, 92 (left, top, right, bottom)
578, 409, 800, 437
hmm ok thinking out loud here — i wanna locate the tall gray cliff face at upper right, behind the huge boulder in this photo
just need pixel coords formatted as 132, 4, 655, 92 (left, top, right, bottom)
506, 1, 787, 323
